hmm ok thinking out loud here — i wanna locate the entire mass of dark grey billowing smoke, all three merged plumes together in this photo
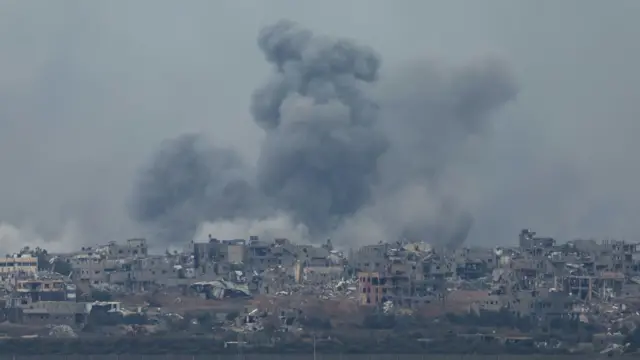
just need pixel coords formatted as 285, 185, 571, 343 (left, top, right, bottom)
132, 21, 517, 247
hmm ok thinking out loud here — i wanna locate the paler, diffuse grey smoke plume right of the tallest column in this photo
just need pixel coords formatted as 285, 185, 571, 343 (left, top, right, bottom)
370, 59, 517, 248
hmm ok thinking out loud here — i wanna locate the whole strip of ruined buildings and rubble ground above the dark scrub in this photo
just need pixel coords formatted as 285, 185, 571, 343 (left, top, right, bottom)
0, 230, 640, 354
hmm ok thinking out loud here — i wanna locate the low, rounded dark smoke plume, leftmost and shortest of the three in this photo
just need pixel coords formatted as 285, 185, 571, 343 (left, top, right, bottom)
131, 134, 261, 244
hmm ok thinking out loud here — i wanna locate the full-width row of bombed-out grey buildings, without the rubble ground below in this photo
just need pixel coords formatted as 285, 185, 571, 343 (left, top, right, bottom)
0, 230, 640, 348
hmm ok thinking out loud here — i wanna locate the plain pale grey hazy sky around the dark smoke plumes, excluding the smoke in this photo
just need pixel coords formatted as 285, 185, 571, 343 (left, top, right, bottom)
0, 0, 640, 253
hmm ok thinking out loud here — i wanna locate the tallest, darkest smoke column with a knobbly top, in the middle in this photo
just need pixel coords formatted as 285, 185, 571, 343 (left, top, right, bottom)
251, 21, 387, 237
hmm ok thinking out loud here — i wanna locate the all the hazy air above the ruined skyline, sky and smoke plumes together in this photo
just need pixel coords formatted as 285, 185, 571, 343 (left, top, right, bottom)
0, 0, 640, 251
